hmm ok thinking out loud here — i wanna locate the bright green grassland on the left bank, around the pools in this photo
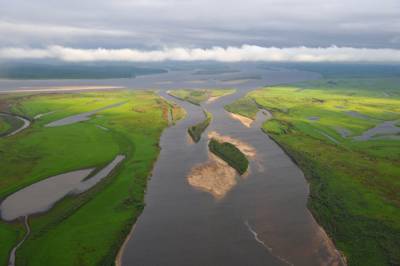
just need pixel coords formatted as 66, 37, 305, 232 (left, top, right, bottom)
0, 91, 180, 265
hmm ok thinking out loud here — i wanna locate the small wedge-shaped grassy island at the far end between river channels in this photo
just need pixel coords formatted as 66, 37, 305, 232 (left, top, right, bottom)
169, 89, 235, 105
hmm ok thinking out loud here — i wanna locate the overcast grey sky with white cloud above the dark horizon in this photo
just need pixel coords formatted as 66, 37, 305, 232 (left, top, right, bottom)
0, 0, 400, 61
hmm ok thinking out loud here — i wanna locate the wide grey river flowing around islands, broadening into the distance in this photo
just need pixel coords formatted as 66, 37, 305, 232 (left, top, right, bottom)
0, 66, 342, 266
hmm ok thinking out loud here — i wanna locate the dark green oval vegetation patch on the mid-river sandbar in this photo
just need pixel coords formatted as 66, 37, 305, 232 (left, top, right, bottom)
208, 139, 249, 175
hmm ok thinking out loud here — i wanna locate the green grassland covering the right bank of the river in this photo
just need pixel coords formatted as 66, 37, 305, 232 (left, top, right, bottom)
228, 78, 400, 265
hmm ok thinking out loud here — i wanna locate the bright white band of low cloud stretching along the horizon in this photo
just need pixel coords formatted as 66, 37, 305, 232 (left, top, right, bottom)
0, 45, 400, 63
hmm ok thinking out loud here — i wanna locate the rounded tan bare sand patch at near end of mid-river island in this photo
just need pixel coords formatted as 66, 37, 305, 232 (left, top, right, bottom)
187, 153, 237, 199
